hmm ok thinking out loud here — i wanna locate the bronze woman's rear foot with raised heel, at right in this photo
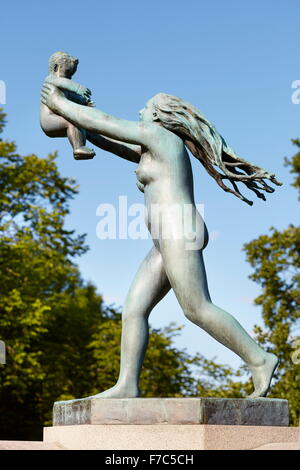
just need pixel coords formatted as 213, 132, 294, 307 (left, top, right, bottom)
248, 353, 279, 398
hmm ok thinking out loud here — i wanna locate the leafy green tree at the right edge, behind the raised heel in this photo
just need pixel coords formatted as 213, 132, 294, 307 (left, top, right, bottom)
245, 139, 300, 425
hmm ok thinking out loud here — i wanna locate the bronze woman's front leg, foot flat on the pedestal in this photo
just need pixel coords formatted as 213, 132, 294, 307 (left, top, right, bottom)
91, 247, 170, 398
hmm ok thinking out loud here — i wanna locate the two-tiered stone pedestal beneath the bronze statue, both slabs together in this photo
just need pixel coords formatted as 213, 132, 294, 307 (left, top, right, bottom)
44, 398, 300, 450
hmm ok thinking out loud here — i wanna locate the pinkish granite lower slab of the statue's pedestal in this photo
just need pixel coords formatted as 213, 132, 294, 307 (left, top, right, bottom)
44, 424, 300, 451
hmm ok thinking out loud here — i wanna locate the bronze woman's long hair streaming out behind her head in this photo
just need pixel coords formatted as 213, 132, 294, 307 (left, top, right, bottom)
153, 93, 282, 205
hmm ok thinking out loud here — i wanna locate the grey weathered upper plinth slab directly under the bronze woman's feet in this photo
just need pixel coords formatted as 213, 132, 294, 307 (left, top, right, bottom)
53, 397, 289, 432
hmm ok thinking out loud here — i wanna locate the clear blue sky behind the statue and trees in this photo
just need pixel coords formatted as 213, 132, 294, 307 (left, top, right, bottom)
0, 0, 300, 366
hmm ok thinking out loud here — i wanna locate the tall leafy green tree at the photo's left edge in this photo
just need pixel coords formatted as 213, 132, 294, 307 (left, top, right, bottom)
0, 105, 91, 438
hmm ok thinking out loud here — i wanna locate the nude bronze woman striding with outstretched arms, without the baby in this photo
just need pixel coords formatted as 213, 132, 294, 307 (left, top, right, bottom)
42, 84, 280, 398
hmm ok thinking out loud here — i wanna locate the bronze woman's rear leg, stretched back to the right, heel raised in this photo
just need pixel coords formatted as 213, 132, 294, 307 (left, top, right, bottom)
161, 242, 278, 397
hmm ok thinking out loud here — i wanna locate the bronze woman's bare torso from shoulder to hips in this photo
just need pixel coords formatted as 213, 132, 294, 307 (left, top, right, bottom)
135, 130, 208, 252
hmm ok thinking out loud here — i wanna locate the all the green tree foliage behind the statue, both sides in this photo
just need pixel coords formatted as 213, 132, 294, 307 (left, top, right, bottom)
0, 103, 300, 439
